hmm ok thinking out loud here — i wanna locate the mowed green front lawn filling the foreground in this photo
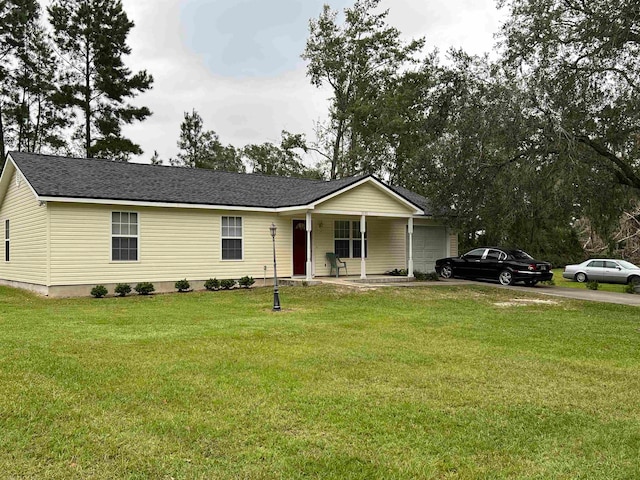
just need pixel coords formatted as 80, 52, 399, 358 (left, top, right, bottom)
0, 285, 640, 479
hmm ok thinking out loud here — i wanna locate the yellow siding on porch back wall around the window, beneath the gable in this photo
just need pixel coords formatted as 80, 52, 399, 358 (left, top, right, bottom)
313, 215, 407, 276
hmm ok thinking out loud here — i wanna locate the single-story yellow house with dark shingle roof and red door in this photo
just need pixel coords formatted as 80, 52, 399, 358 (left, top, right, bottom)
0, 152, 457, 296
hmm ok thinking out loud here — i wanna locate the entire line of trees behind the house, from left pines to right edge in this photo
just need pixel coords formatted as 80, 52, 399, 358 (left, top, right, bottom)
0, 0, 640, 260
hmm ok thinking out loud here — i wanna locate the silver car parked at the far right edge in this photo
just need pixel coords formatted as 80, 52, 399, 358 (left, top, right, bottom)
562, 258, 640, 285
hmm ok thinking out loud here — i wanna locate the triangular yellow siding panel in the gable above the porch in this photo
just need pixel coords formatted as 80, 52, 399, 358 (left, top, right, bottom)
316, 183, 413, 215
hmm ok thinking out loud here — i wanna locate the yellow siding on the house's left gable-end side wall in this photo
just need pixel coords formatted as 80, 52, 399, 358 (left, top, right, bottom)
0, 171, 47, 285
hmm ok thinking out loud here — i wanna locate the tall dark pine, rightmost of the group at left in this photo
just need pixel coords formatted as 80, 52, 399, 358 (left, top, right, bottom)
48, 0, 153, 160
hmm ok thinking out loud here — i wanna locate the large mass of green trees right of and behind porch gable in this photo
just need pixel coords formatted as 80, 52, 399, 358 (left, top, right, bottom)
303, 0, 640, 263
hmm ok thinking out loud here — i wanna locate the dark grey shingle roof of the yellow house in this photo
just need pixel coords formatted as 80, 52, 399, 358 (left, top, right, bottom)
9, 152, 426, 213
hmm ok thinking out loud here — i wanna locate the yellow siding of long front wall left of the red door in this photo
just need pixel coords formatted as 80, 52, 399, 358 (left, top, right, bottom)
50, 203, 292, 285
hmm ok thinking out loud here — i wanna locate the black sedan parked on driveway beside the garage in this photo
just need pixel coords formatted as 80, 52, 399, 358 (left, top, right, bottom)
436, 247, 553, 287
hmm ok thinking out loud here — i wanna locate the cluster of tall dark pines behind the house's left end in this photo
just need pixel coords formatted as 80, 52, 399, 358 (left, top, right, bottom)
0, 0, 153, 161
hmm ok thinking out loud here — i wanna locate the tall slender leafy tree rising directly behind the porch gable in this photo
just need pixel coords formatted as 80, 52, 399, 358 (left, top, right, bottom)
302, 0, 424, 178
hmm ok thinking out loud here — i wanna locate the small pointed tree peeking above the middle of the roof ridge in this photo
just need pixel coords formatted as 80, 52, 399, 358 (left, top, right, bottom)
177, 110, 245, 172
